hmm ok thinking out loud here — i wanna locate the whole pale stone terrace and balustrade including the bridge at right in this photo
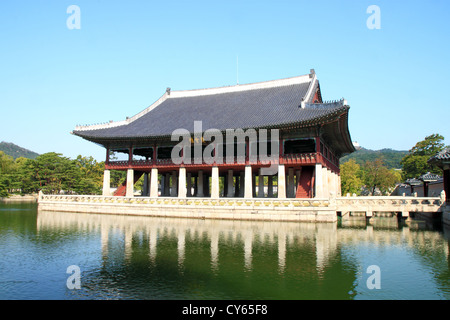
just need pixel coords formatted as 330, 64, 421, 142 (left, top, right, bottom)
38, 192, 445, 222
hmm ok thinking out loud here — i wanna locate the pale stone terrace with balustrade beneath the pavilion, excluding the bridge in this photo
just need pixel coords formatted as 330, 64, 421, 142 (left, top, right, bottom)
38, 193, 337, 222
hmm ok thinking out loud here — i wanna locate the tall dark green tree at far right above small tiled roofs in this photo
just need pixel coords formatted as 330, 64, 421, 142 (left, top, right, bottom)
401, 134, 445, 180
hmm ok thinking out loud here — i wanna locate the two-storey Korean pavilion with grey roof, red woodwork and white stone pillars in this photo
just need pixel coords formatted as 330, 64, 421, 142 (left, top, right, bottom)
73, 70, 355, 198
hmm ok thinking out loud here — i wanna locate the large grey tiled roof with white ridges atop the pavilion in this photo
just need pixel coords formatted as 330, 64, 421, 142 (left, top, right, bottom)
73, 73, 356, 154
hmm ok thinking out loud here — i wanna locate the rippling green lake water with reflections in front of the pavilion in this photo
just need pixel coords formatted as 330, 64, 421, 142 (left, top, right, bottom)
0, 203, 450, 300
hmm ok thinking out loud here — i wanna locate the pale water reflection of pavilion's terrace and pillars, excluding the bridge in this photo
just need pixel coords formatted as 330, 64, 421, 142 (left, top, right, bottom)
37, 211, 337, 270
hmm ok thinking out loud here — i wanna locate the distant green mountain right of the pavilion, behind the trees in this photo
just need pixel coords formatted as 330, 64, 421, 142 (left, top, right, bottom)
340, 148, 408, 169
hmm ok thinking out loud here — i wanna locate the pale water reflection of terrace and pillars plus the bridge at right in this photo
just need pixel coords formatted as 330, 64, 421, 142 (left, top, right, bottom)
37, 211, 449, 272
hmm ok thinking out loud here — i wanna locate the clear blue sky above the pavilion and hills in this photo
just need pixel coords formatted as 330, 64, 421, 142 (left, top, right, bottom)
0, 0, 450, 160
